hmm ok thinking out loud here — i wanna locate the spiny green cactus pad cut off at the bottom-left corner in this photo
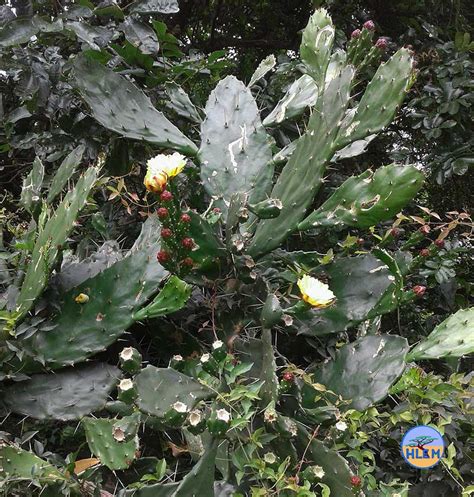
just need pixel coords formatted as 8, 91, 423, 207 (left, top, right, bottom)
0, 442, 66, 483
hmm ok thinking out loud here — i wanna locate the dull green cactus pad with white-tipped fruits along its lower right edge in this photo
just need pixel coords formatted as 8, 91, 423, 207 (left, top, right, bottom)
135, 366, 215, 418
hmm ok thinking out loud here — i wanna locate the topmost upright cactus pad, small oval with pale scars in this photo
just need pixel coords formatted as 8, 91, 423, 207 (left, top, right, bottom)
300, 9, 335, 88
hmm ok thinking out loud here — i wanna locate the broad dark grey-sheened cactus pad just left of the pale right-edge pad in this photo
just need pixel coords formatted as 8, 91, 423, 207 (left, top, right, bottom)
314, 335, 408, 411
